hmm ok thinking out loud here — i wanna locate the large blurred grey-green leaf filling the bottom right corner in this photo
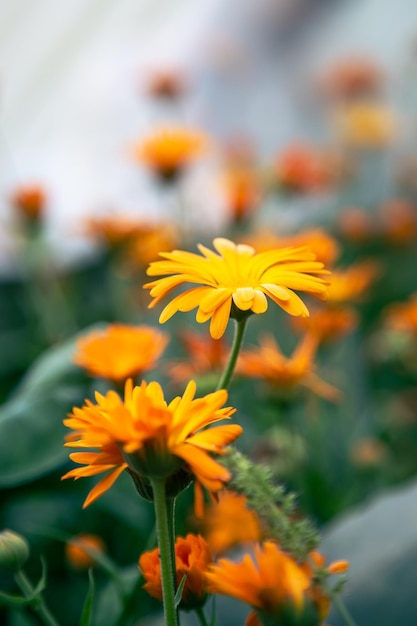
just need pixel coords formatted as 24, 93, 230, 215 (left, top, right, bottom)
322, 482, 417, 626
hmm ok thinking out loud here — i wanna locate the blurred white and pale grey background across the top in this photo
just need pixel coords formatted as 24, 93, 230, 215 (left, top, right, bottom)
0, 0, 417, 265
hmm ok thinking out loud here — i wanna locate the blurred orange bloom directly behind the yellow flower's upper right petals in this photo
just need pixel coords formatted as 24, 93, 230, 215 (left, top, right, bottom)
245, 228, 340, 265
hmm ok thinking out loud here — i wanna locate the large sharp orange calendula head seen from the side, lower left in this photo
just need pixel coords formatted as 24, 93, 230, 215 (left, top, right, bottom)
63, 379, 242, 507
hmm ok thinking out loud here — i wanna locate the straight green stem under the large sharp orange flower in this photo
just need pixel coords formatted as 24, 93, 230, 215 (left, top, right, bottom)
152, 479, 178, 626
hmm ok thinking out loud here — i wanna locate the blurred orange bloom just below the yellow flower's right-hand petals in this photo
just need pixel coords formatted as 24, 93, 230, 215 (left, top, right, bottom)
292, 306, 358, 344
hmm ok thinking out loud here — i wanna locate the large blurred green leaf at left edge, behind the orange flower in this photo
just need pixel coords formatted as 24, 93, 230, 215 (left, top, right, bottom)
0, 330, 90, 488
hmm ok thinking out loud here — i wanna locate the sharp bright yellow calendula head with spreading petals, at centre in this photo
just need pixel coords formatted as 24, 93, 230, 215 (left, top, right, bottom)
144, 238, 327, 339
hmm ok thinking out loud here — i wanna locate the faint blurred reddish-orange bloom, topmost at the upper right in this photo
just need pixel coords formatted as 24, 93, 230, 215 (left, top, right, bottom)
320, 57, 382, 98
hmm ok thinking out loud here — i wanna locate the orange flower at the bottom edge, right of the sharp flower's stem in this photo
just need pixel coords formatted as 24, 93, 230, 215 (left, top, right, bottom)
206, 541, 310, 625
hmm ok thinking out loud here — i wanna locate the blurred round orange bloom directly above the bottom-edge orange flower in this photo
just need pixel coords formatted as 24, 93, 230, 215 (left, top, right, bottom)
202, 491, 261, 554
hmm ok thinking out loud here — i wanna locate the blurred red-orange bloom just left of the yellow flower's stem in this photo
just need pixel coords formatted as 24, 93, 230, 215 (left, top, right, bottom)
169, 330, 229, 382
